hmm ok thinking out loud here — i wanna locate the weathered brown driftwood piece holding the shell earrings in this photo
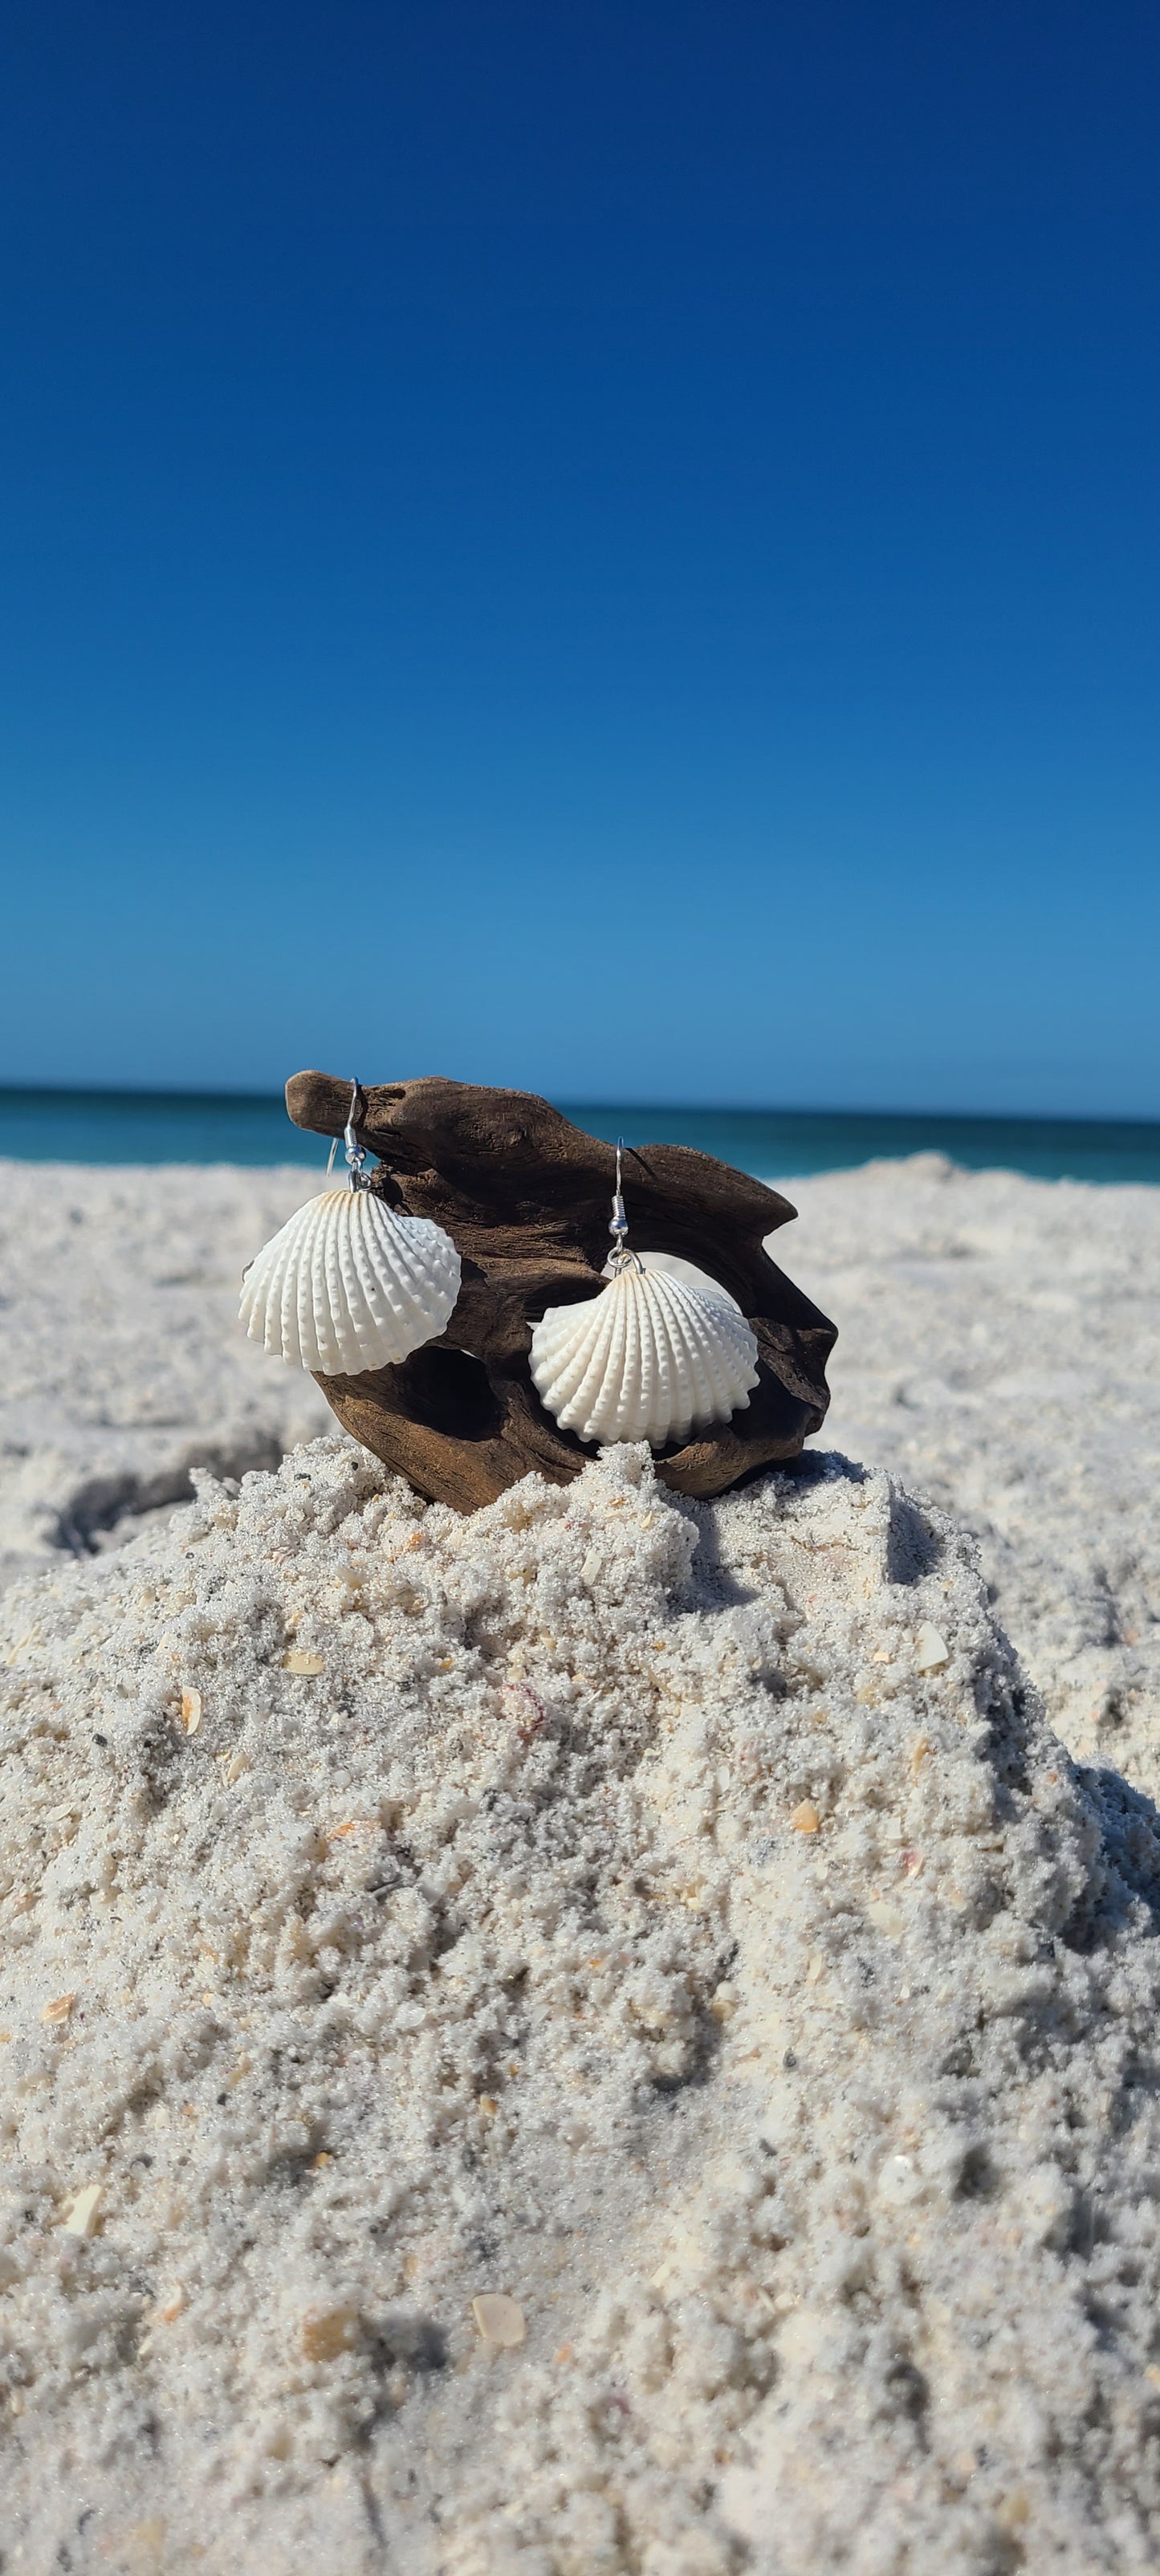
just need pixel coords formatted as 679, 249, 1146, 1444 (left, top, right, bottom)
286, 1074, 835, 1512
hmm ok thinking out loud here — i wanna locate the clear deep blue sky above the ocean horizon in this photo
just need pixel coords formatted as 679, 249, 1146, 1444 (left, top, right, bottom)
0, 0, 1160, 1115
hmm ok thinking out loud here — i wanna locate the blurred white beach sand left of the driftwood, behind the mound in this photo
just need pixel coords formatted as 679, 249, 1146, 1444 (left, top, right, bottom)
0, 1154, 332, 1589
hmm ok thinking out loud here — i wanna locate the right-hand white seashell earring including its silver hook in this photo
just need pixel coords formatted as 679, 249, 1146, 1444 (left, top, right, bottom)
531, 1139, 758, 1448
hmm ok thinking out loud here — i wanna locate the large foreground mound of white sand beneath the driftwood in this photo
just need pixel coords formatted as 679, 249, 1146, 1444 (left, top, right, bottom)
0, 1440, 1160, 2576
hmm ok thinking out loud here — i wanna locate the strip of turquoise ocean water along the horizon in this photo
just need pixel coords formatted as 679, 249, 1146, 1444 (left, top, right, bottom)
0, 1090, 1160, 1185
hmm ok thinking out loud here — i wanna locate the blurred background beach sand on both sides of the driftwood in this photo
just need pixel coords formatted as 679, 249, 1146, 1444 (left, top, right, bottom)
0, 1154, 1160, 1791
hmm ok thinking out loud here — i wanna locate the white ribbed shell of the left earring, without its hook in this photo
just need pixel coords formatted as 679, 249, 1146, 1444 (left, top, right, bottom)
240, 1190, 462, 1378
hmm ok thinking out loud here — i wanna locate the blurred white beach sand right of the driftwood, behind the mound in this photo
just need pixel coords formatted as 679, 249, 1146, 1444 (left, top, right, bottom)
773, 1154, 1160, 1795
